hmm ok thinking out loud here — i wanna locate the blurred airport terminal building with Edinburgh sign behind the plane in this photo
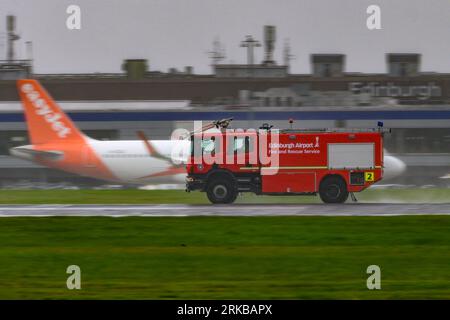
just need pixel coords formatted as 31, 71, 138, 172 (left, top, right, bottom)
0, 20, 450, 186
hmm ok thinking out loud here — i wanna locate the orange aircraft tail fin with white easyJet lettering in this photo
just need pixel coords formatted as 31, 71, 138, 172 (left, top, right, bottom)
17, 79, 84, 144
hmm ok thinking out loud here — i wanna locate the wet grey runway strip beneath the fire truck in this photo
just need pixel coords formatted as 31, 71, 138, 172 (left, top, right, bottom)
0, 203, 450, 217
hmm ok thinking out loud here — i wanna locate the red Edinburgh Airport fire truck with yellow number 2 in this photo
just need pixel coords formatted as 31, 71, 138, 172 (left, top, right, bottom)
186, 123, 386, 203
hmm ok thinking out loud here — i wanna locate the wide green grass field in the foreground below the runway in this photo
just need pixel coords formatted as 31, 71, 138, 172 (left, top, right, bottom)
0, 216, 450, 299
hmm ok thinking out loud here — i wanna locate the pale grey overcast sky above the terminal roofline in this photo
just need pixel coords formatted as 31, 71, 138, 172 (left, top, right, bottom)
0, 0, 450, 73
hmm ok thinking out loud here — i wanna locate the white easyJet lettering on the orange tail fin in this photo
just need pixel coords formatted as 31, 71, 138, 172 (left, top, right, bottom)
21, 83, 70, 138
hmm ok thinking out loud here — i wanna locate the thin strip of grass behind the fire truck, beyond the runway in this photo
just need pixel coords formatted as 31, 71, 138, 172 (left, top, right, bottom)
0, 189, 450, 204
